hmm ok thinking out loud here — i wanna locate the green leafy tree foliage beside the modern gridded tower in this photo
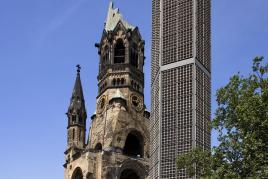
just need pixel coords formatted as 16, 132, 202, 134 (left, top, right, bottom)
177, 57, 268, 178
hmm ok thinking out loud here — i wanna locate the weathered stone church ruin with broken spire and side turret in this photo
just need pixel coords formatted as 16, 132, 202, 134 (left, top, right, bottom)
64, 3, 150, 179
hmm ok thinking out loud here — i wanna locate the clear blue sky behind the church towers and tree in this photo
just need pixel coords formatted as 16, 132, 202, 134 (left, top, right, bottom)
0, 0, 268, 179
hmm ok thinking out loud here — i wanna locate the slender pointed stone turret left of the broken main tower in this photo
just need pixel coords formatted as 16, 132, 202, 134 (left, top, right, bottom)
67, 65, 87, 149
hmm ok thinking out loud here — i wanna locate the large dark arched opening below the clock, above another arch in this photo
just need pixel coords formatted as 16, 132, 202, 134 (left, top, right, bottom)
123, 131, 144, 157
